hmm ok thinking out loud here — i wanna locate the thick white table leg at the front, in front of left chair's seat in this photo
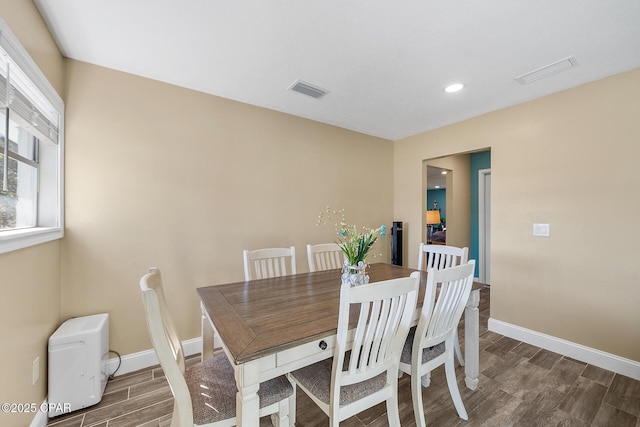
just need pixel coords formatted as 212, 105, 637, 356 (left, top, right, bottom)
235, 363, 260, 427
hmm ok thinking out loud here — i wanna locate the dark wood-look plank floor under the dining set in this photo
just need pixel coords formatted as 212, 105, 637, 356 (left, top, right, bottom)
49, 289, 640, 427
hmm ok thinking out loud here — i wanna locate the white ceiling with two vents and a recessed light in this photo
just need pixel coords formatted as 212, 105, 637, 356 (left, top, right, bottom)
34, 0, 640, 140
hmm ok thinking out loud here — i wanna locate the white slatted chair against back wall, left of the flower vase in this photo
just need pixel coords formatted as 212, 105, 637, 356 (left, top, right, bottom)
242, 246, 296, 280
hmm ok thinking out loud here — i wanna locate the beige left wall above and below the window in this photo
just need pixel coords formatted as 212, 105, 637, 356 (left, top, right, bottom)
0, 0, 64, 426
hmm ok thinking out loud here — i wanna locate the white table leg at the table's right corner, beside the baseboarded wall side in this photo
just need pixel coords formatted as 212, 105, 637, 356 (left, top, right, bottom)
464, 289, 480, 390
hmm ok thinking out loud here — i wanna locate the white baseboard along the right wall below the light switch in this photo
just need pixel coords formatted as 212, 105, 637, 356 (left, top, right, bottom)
488, 318, 640, 380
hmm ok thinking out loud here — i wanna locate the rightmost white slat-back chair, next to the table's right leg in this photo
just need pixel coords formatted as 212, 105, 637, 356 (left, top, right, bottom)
400, 260, 475, 427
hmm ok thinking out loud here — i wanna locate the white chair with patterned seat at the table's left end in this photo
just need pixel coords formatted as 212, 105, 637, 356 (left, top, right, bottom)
140, 268, 295, 427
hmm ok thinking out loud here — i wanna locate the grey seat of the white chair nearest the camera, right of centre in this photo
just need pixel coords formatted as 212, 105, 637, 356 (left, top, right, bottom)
291, 352, 387, 405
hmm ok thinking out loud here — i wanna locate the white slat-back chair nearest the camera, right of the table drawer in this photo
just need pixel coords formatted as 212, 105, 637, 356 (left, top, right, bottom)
289, 272, 420, 427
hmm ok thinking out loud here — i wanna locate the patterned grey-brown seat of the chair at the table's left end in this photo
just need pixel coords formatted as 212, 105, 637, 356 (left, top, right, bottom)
185, 353, 293, 424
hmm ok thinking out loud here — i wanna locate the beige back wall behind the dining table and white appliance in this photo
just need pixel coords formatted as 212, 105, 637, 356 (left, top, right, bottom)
62, 61, 393, 354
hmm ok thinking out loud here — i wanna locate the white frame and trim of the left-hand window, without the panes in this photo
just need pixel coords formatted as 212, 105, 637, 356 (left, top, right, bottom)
0, 18, 64, 253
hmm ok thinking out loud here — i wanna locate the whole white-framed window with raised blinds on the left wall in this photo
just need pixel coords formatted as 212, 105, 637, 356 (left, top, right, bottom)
0, 19, 64, 253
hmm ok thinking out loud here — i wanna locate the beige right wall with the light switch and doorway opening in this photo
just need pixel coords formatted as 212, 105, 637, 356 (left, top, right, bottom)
394, 69, 640, 361
